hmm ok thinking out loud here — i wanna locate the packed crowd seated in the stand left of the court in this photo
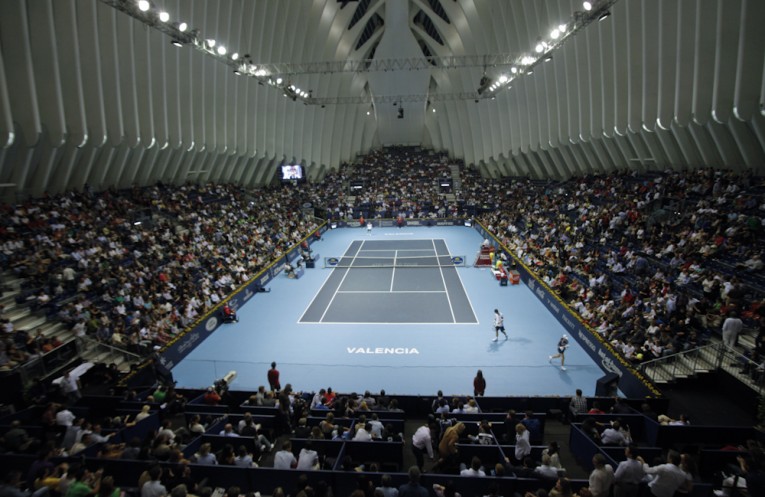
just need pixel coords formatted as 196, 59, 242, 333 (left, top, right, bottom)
0, 184, 317, 367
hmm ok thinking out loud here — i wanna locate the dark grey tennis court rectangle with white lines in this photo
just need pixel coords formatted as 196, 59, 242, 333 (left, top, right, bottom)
300, 239, 478, 324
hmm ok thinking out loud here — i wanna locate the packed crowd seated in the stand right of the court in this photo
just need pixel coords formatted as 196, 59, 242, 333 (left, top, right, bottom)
471, 170, 765, 362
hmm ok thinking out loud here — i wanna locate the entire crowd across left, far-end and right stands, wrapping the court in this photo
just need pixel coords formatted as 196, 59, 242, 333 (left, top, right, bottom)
0, 147, 765, 376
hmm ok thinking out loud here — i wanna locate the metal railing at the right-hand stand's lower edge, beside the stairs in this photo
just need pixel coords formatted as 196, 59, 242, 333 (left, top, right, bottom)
637, 342, 765, 395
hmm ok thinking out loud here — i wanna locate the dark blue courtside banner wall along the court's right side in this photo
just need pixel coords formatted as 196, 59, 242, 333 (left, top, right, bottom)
474, 222, 662, 399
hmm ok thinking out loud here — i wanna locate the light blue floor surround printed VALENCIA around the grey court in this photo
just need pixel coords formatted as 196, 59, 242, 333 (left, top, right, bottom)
173, 226, 603, 396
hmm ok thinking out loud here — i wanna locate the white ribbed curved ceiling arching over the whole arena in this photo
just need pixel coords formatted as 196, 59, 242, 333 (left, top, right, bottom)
0, 0, 765, 197
